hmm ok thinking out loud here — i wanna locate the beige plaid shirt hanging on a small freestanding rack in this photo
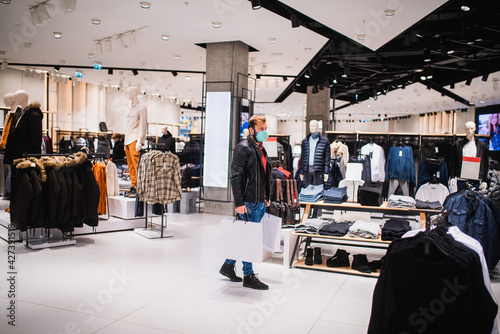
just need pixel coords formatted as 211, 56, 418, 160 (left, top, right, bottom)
137, 151, 182, 204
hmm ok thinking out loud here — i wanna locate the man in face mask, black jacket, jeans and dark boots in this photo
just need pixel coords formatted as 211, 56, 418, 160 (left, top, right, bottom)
219, 115, 271, 290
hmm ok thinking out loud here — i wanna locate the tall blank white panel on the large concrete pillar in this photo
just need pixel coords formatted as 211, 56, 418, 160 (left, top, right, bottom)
203, 92, 231, 188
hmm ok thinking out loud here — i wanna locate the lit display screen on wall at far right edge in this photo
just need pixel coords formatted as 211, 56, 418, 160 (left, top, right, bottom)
476, 105, 500, 152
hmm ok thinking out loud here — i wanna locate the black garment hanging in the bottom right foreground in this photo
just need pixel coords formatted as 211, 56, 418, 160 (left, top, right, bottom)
368, 227, 497, 334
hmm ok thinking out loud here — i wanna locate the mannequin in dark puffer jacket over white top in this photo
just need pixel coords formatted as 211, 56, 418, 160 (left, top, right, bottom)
299, 120, 330, 187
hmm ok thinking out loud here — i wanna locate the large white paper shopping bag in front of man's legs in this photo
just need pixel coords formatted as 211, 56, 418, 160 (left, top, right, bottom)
217, 218, 264, 262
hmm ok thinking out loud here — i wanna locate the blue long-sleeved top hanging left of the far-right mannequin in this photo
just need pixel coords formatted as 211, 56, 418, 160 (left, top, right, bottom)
385, 146, 416, 188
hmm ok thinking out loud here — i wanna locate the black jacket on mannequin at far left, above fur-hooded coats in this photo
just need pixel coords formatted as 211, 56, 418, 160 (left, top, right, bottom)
4, 102, 43, 164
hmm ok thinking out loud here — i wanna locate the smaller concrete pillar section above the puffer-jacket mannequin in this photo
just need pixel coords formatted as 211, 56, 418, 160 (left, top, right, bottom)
306, 86, 331, 135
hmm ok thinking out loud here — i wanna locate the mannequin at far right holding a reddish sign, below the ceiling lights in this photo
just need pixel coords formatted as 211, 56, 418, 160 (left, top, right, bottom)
450, 122, 488, 190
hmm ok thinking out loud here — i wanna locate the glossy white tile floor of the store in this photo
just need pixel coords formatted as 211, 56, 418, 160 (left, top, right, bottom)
0, 214, 500, 334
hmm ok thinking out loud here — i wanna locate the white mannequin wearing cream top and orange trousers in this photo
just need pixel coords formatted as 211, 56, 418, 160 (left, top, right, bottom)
125, 86, 148, 197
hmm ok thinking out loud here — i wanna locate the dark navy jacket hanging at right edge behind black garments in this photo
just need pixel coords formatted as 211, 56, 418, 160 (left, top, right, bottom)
443, 190, 500, 270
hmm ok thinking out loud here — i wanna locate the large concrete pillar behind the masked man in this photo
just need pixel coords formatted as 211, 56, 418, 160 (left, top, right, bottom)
204, 41, 249, 215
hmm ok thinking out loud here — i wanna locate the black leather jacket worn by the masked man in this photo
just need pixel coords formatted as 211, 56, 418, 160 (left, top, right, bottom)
231, 137, 271, 207
